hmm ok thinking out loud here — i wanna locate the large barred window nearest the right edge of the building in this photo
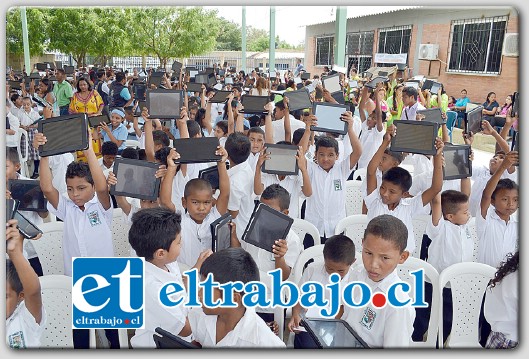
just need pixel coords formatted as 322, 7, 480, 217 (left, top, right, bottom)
448, 16, 507, 74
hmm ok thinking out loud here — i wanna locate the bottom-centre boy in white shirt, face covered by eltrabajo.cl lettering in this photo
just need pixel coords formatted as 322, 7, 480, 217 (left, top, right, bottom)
188, 248, 285, 348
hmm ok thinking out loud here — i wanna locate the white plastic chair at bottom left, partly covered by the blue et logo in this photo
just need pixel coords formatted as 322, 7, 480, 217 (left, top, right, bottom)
39, 276, 96, 349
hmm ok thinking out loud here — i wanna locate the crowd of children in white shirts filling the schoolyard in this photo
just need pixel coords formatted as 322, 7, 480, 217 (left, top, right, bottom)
6, 61, 519, 348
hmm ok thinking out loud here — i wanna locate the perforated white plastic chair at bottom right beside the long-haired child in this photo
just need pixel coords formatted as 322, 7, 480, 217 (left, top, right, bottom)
439, 262, 496, 348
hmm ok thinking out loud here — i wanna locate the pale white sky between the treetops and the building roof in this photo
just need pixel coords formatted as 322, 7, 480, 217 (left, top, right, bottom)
205, 6, 409, 45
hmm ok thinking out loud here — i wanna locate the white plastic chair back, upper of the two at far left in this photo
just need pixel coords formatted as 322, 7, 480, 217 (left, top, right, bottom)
31, 222, 64, 276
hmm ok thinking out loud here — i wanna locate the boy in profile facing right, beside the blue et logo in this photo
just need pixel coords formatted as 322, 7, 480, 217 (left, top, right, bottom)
129, 208, 211, 348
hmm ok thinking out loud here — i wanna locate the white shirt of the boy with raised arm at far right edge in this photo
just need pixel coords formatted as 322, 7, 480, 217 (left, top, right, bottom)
476, 205, 518, 268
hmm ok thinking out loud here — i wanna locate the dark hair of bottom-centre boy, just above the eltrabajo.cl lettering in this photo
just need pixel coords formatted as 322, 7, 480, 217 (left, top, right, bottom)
200, 247, 259, 284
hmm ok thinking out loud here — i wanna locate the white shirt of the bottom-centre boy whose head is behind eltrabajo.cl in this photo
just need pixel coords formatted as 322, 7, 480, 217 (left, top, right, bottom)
188, 308, 285, 348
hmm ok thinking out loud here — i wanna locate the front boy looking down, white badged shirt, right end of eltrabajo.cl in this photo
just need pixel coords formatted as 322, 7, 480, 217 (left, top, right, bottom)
342, 214, 415, 348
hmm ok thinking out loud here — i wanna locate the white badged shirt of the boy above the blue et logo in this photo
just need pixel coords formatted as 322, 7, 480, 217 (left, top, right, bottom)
48, 194, 114, 276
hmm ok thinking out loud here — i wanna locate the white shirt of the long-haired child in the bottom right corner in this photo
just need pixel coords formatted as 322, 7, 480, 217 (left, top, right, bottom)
484, 271, 519, 342
